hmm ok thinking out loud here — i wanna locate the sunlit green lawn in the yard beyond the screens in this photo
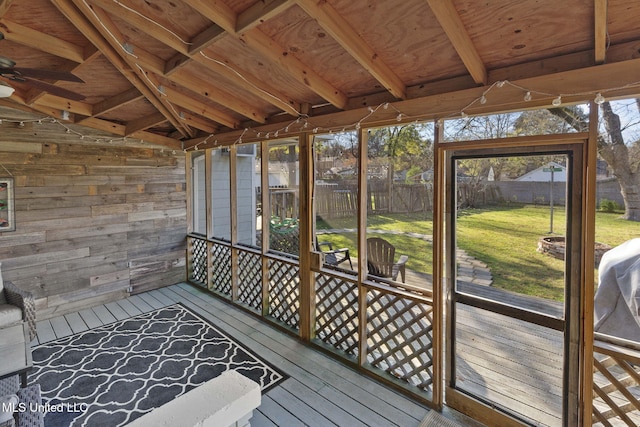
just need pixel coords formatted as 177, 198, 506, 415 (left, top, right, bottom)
316, 205, 640, 300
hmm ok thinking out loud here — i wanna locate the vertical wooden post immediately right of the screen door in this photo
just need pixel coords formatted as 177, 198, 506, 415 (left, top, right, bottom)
578, 102, 600, 426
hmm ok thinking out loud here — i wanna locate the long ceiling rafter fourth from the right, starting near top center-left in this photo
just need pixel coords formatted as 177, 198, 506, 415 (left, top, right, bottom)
184, 0, 348, 109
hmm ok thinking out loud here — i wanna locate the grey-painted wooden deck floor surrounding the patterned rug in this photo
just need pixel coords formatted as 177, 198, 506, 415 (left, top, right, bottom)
34, 284, 479, 427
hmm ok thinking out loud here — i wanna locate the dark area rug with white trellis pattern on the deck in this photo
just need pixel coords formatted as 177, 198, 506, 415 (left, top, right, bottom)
29, 304, 286, 427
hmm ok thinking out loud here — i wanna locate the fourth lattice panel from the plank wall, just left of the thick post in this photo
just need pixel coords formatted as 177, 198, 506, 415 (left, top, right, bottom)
269, 259, 300, 330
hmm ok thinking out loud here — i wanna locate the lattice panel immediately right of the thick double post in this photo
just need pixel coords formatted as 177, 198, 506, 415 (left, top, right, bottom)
316, 273, 358, 356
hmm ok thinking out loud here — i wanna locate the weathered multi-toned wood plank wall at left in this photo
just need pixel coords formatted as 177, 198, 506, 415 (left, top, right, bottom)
0, 121, 187, 319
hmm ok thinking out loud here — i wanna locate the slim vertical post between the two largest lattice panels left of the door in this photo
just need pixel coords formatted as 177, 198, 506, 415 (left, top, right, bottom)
357, 129, 369, 366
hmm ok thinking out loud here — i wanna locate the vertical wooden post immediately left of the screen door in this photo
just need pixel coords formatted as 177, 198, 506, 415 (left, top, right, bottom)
432, 121, 444, 409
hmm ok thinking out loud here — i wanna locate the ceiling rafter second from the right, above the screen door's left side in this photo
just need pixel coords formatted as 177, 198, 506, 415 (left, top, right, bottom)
427, 0, 487, 84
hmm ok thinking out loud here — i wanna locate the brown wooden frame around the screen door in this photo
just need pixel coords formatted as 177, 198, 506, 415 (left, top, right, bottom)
433, 132, 589, 426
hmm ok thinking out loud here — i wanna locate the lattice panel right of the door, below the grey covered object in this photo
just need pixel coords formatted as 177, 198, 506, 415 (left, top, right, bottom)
592, 341, 640, 426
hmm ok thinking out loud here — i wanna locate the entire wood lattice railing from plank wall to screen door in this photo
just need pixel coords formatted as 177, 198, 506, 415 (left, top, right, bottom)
188, 236, 433, 399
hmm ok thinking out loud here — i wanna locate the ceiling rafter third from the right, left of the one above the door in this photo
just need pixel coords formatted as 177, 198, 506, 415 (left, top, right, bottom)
296, 0, 406, 99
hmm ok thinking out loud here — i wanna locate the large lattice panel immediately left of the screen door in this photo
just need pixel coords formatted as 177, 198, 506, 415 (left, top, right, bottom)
367, 289, 433, 390
